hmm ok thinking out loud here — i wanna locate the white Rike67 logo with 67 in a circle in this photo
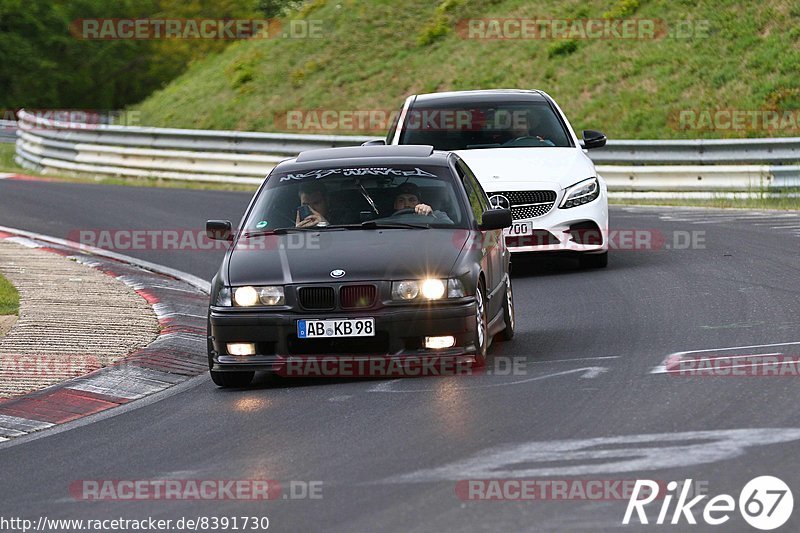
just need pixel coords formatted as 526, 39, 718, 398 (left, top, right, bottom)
622, 476, 794, 531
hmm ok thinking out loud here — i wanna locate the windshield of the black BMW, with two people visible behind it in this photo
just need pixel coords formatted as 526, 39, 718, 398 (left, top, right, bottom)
244, 165, 467, 229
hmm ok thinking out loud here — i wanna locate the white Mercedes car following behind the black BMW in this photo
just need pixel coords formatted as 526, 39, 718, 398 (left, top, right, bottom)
378, 89, 608, 268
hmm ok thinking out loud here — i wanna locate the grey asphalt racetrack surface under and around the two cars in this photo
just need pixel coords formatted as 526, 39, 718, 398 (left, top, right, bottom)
0, 180, 800, 532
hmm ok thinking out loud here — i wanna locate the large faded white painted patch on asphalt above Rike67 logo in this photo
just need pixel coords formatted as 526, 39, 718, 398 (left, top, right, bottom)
379, 428, 800, 483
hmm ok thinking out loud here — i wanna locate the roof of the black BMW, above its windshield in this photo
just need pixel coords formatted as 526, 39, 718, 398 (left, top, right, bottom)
276, 144, 450, 172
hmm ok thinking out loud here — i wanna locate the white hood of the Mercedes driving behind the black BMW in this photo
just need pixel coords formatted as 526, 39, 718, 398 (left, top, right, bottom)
456, 148, 597, 192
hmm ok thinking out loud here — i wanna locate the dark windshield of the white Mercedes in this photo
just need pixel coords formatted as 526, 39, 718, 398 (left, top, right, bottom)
400, 102, 572, 150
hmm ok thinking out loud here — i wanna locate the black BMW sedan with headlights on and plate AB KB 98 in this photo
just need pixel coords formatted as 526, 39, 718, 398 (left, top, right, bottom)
206, 146, 514, 387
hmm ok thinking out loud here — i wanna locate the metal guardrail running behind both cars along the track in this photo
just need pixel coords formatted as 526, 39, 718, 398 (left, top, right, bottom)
16, 111, 800, 191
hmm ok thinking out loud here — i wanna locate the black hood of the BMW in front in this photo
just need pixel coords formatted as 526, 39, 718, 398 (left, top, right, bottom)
228, 229, 469, 286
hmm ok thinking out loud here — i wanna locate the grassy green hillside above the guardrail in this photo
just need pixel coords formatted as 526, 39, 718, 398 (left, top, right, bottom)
135, 0, 800, 139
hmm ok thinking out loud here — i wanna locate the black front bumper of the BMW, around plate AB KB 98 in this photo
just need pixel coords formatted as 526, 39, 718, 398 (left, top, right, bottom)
209, 298, 475, 373
